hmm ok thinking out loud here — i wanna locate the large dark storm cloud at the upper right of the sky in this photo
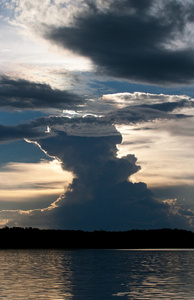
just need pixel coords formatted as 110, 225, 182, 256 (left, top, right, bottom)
44, 0, 194, 85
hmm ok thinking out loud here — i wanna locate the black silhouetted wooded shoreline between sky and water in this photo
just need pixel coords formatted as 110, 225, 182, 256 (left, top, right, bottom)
0, 227, 194, 249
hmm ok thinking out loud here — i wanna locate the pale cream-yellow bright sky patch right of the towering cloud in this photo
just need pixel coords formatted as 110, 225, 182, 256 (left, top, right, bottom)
117, 118, 194, 188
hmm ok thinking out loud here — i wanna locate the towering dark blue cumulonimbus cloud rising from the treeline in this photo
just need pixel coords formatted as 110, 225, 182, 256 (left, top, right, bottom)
33, 123, 190, 230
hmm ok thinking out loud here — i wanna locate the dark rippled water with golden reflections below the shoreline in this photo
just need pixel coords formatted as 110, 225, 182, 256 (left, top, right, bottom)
0, 250, 194, 300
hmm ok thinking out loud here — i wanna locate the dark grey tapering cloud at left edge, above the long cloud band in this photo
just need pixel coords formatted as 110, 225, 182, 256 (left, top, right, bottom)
0, 76, 84, 110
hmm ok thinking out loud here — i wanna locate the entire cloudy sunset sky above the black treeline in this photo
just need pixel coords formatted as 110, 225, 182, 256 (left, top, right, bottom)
0, 0, 194, 231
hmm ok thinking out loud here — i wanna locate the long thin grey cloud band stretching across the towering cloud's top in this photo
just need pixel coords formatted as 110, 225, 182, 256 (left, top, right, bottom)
0, 96, 193, 143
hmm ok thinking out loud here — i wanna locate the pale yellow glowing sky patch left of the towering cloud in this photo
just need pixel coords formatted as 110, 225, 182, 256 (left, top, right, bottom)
0, 160, 73, 206
